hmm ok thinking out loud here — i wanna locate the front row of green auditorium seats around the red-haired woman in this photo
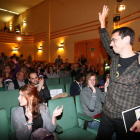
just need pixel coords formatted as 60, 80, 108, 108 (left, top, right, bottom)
0, 93, 97, 140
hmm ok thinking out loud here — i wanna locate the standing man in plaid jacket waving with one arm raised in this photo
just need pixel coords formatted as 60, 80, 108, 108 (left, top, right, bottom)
97, 6, 140, 140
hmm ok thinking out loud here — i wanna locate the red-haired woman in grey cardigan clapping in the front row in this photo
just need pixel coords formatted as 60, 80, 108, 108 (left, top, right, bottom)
12, 84, 63, 140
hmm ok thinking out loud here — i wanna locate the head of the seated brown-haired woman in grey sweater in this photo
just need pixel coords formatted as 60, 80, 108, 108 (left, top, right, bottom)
86, 72, 98, 87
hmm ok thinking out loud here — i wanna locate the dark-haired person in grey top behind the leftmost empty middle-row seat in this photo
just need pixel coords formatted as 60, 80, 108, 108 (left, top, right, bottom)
46, 65, 60, 78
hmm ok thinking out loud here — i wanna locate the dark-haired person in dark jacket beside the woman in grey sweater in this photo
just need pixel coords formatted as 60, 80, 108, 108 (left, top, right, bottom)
70, 73, 85, 96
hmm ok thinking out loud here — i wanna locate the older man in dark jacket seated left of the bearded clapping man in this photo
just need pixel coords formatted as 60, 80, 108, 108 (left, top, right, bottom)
8, 70, 28, 90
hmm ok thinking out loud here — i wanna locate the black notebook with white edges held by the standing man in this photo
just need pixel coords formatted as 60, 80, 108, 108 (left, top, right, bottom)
122, 106, 140, 133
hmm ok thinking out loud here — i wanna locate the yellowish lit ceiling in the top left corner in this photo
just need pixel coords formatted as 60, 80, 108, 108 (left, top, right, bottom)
0, 0, 44, 23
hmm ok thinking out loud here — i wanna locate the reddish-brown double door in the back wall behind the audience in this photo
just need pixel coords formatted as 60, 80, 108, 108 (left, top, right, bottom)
74, 38, 107, 74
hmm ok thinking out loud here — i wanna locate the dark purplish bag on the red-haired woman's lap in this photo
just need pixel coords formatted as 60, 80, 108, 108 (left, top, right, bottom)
31, 128, 54, 140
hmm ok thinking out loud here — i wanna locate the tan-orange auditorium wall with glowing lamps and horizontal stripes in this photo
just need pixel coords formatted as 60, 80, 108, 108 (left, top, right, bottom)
1, 0, 140, 63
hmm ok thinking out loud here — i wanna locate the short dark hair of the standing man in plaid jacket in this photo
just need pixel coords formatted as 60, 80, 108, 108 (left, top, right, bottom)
112, 27, 135, 45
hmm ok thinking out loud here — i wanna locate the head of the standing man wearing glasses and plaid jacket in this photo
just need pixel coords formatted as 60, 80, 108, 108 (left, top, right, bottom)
110, 27, 135, 54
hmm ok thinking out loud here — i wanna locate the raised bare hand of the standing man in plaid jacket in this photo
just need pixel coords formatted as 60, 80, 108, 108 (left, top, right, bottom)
99, 5, 109, 28
